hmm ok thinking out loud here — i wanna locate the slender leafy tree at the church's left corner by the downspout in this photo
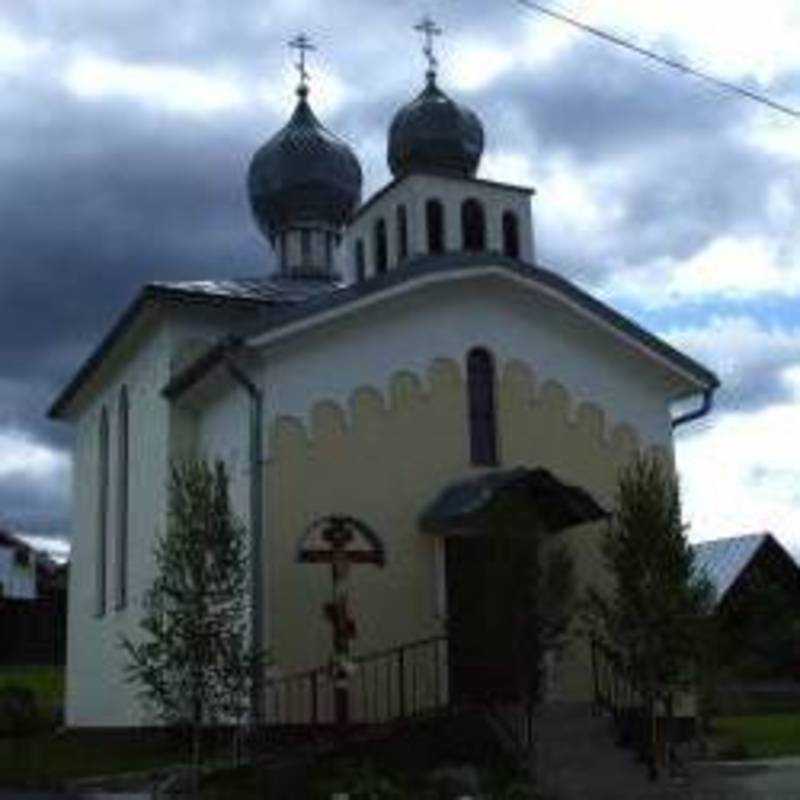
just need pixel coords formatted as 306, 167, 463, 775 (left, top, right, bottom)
122, 460, 263, 784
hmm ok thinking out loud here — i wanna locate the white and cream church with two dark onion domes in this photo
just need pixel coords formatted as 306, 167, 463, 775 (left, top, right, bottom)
51, 47, 718, 726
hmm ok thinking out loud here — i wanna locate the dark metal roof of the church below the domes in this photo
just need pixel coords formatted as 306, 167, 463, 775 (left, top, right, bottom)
54, 253, 719, 417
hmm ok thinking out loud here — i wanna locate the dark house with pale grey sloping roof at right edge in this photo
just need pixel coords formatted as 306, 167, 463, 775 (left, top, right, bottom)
693, 532, 800, 679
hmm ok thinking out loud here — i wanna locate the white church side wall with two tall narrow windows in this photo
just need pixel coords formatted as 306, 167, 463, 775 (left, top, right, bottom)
66, 327, 171, 727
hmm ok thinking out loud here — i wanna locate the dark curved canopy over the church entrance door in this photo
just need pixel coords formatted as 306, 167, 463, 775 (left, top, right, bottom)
419, 467, 609, 537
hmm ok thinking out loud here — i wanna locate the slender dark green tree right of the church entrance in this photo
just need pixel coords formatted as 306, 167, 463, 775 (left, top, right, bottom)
585, 455, 713, 728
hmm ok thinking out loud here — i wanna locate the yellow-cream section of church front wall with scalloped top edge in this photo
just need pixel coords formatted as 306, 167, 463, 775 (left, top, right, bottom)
266, 359, 664, 698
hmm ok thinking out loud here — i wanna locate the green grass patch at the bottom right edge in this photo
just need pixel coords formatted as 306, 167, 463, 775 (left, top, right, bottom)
714, 714, 800, 758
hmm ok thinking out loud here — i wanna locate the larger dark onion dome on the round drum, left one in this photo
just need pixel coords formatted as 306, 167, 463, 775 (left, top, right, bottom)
247, 88, 361, 239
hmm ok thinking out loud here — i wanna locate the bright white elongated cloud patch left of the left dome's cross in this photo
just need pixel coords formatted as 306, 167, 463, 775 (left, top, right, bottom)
63, 53, 247, 114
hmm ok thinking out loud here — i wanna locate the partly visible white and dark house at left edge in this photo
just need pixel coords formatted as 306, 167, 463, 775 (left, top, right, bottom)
0, 530, 67, 665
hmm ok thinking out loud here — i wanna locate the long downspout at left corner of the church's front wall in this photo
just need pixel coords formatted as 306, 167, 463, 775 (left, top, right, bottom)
224, 354, 264, 725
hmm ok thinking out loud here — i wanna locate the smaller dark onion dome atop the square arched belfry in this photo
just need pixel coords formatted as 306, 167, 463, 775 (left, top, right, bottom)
388, 72, 483, 177
